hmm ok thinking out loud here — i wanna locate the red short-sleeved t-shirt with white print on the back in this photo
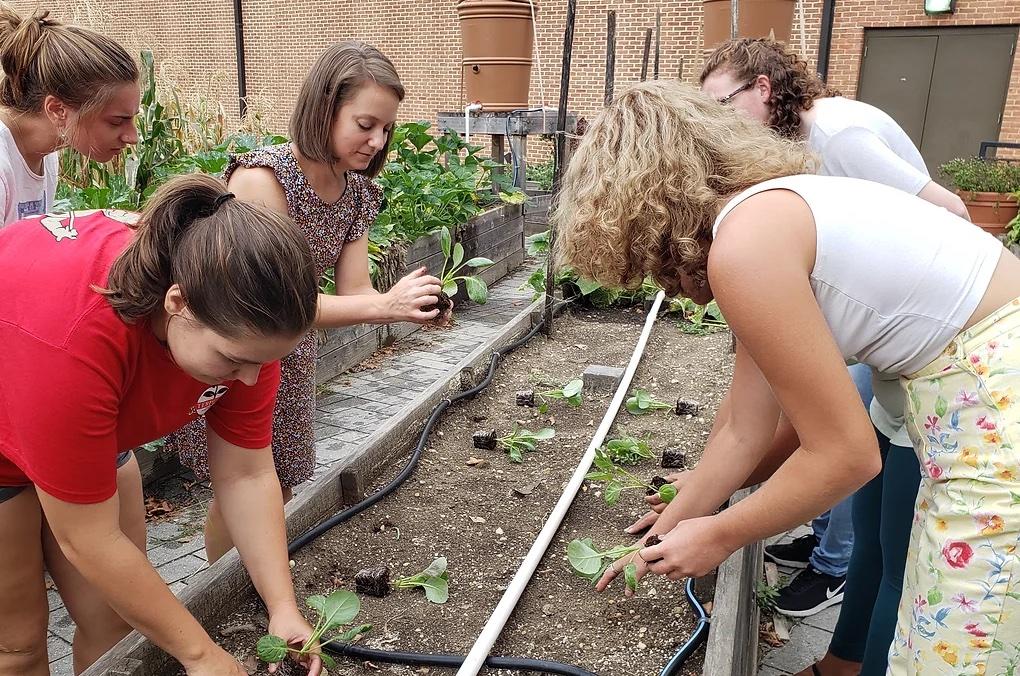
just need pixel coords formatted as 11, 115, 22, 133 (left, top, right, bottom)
0, 211, 279, 503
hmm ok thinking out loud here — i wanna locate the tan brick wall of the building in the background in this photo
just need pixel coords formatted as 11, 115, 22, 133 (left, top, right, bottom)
5, 0, 1020, 148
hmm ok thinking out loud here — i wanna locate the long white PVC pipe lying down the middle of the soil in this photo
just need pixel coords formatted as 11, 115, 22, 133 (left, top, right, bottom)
457, 291, 666, 676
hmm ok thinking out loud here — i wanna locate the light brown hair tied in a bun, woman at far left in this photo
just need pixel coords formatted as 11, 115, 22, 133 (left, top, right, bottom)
0, 3, 139, 115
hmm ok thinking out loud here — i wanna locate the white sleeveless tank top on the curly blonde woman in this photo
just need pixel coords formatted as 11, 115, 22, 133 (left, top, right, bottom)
712, 175, 1003, 375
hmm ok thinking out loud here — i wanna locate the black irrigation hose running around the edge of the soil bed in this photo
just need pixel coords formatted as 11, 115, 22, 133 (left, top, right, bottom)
287, 301, 709, 676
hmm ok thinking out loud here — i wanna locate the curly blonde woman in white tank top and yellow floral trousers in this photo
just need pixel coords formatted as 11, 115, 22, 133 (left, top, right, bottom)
555, 82, 1020, 675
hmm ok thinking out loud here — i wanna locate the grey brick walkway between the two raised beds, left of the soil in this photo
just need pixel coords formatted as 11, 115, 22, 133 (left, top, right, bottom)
47, 264, 533, 676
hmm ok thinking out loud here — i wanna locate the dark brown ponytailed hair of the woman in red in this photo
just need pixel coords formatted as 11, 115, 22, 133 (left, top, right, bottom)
96, 174, 318, 337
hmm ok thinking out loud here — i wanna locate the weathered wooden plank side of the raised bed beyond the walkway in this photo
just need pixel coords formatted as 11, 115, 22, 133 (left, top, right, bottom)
315, 204, 524, 383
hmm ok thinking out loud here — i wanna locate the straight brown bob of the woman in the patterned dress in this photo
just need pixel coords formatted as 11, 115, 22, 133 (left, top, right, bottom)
291, 41, 404, 176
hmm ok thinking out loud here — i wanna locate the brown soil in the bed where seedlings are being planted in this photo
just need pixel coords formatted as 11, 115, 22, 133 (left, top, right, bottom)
194, 309, 732, 676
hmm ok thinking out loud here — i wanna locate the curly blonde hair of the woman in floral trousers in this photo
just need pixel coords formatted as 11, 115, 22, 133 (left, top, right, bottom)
552, 81, 815, 295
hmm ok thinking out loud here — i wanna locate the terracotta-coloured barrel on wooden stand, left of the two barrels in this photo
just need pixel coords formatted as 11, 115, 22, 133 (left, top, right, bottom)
457, 0, 539, 111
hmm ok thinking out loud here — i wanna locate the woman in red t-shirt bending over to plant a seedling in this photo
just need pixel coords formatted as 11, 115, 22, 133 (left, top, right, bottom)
0, 175, 320, 676
